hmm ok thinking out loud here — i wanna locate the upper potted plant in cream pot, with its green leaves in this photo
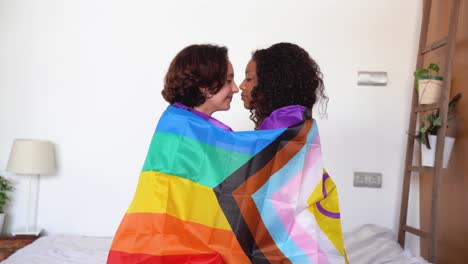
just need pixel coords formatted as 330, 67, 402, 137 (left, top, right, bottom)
414, 62, 443, 105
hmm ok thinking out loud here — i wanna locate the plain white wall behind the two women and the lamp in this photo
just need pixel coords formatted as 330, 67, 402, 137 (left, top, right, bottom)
0, 0, 422, 243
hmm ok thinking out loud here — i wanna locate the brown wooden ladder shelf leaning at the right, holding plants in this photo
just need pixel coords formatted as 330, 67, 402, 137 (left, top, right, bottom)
398, 0, 460, 263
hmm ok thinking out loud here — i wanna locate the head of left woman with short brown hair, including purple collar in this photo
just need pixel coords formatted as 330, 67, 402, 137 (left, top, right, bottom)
162, 44, 239, 131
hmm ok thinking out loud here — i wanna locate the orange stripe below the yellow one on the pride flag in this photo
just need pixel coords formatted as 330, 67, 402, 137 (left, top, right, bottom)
111, 213, 250, 264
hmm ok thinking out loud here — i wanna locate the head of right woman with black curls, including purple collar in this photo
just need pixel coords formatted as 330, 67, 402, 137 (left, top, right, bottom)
239, 43, 328, 129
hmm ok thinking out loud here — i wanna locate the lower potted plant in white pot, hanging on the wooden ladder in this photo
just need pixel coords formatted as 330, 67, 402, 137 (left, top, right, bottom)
416, 93, 461, 168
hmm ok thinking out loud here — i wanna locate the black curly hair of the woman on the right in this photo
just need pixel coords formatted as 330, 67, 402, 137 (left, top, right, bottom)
250, 42, 328, 128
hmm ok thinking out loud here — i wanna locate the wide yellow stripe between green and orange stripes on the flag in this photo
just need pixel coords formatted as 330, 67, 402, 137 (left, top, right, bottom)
127, 171, 231, 230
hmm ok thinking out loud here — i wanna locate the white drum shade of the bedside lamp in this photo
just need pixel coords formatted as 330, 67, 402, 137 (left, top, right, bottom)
7, 139, 55, 174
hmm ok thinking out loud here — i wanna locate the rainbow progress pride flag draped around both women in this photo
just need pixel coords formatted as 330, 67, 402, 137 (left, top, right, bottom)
108, 106, 347, 264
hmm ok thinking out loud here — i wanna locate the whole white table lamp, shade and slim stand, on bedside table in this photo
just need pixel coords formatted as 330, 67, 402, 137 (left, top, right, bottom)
7, 139, 55, 235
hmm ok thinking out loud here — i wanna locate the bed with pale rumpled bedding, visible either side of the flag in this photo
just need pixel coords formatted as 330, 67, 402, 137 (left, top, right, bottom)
2, 224, 428, 264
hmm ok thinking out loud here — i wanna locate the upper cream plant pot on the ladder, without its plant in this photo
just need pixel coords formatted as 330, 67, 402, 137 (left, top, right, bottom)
418, 76, 442, 105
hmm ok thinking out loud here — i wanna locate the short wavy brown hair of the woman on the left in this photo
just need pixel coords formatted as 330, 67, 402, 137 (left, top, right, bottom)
161, 44, 229, 107
